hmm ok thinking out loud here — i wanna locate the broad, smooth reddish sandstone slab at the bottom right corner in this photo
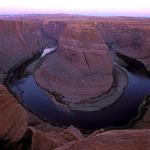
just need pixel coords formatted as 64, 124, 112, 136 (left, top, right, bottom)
55, 130, 150, 150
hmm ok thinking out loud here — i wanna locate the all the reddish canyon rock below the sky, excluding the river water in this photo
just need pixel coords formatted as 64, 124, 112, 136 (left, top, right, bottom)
0, 15, 150, 150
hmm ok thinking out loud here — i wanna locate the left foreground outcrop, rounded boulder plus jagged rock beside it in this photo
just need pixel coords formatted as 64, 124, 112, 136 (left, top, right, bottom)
0, 85, 84, 150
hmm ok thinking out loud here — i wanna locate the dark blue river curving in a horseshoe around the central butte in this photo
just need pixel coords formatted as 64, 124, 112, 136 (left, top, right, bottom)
6, 47, 150, 129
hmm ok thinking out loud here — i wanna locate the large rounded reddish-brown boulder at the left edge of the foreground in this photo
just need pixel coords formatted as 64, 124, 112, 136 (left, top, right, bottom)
0, 85, 27, 142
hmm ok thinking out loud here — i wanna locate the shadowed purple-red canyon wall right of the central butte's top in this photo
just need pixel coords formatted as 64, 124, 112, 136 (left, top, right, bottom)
97, 18, 150, 68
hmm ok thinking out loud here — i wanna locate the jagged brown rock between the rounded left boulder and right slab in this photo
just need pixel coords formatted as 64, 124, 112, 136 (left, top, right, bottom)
29, 127, 83, 150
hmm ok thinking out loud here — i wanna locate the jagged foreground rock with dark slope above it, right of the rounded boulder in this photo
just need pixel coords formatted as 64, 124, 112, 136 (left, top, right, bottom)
28, 112, 84, 150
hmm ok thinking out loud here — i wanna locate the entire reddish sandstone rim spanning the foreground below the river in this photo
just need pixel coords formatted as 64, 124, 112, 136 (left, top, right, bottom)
0, 85, 150, 150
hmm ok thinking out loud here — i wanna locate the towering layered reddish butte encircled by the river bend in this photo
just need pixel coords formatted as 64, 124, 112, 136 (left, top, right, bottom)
35, 22, 113, 101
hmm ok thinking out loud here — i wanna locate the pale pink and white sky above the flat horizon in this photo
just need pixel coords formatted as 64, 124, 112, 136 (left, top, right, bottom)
0, 0, 150, 17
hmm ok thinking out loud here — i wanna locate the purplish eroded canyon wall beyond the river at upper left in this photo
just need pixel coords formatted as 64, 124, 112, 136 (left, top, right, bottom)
0, 20, 55, 82
